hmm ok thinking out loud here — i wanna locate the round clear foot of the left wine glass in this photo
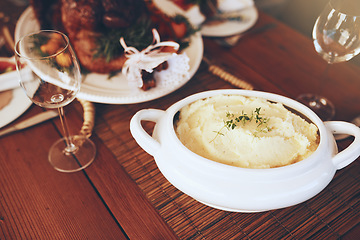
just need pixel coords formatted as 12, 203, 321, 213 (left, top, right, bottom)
49, 135, 96, 173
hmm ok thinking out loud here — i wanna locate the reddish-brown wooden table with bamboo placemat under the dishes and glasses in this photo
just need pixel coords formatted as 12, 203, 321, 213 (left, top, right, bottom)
0, 2, 360, 239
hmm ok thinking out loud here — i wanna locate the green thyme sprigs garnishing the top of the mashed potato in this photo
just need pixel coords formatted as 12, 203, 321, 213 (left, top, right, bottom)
210, 107, 271, 142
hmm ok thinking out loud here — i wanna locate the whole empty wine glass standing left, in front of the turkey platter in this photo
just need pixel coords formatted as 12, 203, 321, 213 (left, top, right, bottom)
15, 30, 96, 172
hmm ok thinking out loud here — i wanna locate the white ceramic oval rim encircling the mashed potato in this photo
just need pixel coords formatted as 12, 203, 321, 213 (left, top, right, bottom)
164, 89, 329, 174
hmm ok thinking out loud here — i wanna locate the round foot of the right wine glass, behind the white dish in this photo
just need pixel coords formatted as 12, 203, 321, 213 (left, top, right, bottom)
296, 94, 335, 121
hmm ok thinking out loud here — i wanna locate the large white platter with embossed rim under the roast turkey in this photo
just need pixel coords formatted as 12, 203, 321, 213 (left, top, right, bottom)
15, 7, 204, 104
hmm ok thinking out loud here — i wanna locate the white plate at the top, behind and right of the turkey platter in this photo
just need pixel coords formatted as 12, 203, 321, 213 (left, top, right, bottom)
201, 6, 259, 37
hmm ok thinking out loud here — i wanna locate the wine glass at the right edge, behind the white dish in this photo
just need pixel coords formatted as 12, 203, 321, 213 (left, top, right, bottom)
297, 0, 360, 121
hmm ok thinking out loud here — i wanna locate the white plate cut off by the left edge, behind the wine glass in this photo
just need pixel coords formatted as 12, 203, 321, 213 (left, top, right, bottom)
0, 58, 32, 128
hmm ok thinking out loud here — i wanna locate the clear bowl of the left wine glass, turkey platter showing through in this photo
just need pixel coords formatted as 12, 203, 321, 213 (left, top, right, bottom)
16, 31, 81, 108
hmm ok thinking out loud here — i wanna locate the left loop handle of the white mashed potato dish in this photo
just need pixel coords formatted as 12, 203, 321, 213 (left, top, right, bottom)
130, 109, 165, 156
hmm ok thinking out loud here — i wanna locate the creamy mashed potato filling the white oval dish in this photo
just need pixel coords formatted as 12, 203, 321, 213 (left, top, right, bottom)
175, 95, 319, 168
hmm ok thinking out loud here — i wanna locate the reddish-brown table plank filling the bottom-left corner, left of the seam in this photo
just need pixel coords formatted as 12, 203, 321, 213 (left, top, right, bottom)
0, 106, 127, 239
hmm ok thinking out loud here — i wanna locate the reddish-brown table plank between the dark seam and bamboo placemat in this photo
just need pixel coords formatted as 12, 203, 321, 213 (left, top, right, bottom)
72, 102, 177, 240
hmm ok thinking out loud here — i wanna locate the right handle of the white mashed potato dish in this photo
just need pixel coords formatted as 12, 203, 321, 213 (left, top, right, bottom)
325, 121, 360, 169
